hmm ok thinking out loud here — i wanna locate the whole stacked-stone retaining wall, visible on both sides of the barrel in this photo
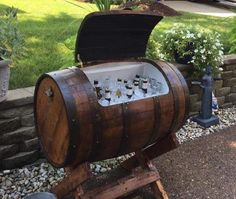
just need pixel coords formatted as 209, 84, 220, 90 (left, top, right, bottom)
0, 55, 236, 170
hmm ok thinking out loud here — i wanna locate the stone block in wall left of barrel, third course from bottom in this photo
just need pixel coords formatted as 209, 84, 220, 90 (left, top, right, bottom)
0, 127, 36, 144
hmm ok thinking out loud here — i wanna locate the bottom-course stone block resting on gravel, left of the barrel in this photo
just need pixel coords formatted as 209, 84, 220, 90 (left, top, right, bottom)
0, 151, 39, 169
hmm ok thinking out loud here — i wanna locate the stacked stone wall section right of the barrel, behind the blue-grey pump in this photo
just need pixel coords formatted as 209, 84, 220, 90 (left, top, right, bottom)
178, 55, 236, 115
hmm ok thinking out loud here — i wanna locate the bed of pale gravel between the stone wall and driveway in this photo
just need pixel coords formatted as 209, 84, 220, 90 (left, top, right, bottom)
0, 107, 236, 199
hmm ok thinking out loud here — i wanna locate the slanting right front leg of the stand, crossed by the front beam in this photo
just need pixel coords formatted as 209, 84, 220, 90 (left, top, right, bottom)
135, 152, 169, 199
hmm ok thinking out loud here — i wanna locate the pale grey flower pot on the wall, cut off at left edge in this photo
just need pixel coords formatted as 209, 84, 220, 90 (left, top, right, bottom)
0, 60, 11, 102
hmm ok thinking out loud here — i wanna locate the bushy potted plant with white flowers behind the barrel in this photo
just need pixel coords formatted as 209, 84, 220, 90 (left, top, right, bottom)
160, 25, 223, 77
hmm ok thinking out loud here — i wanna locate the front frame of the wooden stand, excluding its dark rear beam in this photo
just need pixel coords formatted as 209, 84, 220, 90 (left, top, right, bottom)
52, 151, 168, 199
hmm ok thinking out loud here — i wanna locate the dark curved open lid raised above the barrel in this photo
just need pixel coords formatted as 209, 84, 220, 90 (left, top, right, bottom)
75, 10, 163, 62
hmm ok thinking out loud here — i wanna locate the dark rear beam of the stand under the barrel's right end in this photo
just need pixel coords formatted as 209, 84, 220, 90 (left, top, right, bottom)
121, 133, 179, 171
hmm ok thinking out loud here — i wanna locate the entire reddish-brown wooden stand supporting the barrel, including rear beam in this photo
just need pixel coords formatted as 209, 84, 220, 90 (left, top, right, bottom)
52, 136, 176, 199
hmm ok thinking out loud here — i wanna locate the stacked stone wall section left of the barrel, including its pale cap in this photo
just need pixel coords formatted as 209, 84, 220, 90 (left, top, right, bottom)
0, 87, 39, 170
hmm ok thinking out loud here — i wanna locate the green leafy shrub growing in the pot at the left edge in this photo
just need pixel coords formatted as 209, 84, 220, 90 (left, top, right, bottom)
0, 7, 24, 60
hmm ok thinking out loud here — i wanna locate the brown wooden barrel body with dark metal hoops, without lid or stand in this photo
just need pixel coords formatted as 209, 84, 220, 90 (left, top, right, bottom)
34, 60, 189, 167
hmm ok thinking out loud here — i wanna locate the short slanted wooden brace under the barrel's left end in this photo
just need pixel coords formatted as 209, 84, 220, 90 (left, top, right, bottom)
51, 163, 91, 199
